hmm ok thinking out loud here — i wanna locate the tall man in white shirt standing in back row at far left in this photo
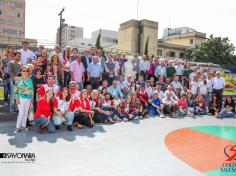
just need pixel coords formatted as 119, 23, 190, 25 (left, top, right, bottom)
18, 41, 36, 65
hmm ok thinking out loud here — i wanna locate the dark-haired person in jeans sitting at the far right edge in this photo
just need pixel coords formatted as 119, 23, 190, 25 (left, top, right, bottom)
216, 96, 236, 119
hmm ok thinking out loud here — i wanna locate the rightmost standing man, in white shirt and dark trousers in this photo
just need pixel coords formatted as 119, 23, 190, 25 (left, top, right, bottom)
213, 71, 225, 106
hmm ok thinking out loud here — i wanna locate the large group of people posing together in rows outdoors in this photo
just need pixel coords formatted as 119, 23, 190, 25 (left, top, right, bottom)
0, 42, 235, 133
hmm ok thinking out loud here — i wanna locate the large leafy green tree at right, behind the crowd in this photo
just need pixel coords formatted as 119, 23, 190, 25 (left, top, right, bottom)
188, 35, 235, 64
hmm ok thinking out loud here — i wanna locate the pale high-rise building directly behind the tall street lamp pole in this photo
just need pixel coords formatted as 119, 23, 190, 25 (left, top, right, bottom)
56, 24, 84, 48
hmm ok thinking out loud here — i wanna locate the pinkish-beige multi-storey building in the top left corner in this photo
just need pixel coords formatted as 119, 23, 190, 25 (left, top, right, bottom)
0, 0, 37, 54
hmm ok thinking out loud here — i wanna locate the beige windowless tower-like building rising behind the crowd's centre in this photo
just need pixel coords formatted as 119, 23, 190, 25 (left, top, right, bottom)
118, 19, 158, 55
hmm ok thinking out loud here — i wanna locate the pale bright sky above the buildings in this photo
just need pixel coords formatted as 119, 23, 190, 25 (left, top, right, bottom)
26, 0, 236, 45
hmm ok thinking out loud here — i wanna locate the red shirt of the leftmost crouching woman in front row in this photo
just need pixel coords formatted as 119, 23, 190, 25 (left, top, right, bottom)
34, 98, 52, 118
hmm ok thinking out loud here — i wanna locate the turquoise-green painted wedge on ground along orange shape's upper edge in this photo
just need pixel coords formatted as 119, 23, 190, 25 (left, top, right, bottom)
190, 126, 236, 142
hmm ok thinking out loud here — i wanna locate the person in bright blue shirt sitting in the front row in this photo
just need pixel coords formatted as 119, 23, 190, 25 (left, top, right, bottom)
148, 91, 165, 118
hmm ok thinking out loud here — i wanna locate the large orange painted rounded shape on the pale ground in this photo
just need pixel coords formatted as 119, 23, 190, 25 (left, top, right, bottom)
165, 128, 235, 172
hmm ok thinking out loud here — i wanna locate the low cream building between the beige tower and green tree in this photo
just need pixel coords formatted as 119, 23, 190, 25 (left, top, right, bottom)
163, 31, 206, 47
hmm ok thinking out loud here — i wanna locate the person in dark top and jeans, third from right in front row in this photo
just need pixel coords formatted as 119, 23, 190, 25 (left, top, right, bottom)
194, 94, 208, 115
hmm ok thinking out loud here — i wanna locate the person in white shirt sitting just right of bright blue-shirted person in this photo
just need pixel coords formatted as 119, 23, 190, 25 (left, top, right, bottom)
162, 92, 178, 118
